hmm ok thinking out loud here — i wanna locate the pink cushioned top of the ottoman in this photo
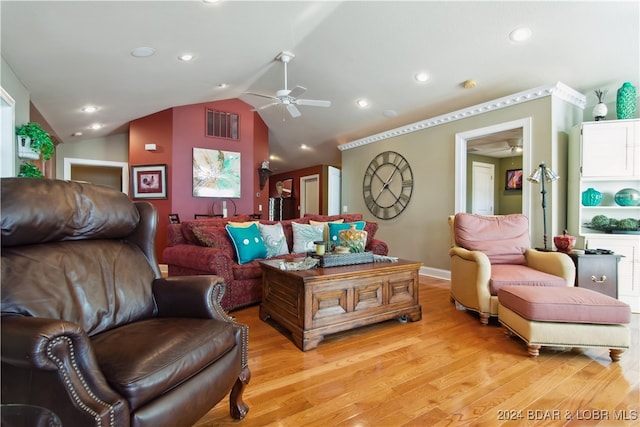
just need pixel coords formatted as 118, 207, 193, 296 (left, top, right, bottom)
498, 286, 631, 324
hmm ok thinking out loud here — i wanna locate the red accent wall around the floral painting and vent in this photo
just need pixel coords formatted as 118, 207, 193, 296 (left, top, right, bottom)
129, 99, 269, 262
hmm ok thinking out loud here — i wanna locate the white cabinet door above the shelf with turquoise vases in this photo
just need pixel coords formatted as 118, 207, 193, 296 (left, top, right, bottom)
582, 120, 639, 178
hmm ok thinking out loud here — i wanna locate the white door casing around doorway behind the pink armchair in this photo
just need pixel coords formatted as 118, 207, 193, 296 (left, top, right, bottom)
454, 117, 532, 221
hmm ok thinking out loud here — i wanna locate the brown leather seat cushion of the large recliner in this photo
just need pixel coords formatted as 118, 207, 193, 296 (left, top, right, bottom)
92, 318, 235, 411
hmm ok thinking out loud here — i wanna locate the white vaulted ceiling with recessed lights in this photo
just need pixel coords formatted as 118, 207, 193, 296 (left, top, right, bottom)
0, 0, 640, 172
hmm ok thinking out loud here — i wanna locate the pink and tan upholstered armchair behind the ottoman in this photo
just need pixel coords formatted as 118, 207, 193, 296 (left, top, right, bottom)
449, 213, 575, 325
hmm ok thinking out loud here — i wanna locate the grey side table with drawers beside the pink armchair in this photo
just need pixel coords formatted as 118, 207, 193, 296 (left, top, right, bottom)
569, 253, 622, 298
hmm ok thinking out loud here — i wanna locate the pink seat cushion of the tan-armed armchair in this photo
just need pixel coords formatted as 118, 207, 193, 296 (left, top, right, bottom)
489, 264, 567, 296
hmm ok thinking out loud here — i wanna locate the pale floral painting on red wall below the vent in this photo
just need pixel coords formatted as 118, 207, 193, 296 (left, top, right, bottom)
193, 148, 241, 198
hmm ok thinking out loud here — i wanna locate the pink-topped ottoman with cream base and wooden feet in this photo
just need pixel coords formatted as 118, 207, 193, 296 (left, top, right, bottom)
498, 286, 631, 362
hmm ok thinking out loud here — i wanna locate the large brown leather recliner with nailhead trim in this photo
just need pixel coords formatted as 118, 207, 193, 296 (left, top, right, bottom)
1, 178, 250, 427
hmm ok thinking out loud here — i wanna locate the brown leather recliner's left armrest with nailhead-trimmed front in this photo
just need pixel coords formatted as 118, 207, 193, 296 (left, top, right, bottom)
0, 316, 129, 425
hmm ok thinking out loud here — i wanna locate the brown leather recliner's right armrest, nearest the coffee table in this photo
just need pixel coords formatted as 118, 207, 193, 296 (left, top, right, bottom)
153, 275, 231, 321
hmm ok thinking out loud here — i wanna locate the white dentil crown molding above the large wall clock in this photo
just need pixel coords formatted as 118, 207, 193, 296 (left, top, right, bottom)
338, 82, 587, 151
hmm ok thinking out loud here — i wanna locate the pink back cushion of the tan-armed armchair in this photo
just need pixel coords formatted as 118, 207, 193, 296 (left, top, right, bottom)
454, 213, 531, 264
